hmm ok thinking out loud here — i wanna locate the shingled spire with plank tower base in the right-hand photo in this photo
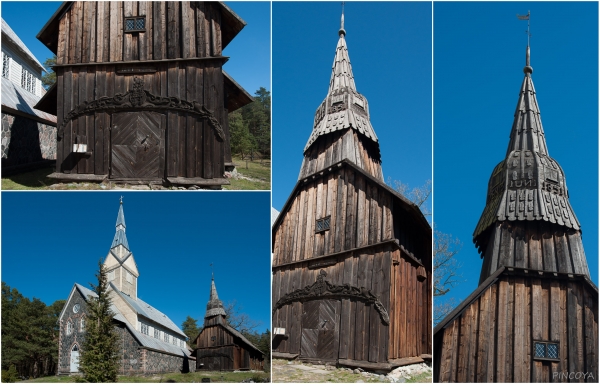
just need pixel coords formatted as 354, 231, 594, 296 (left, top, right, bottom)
473, 46, 589, 282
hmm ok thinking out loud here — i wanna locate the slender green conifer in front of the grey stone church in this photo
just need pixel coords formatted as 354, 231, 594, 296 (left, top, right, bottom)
79, 261, 119, 383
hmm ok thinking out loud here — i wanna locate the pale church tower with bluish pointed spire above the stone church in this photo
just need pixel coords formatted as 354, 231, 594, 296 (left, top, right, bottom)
104, 198, 140, 299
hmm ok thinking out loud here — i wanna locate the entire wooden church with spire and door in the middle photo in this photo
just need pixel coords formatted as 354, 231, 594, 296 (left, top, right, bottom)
272, 16, 432, 370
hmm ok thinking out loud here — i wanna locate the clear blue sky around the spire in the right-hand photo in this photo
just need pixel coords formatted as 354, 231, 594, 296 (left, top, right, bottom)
434, 2, 598, 312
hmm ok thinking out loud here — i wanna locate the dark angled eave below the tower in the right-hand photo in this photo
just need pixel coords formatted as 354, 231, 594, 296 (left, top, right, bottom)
433, 266, 598, 336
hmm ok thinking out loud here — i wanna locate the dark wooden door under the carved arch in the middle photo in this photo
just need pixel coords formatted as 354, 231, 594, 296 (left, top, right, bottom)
300, 300, 340, 360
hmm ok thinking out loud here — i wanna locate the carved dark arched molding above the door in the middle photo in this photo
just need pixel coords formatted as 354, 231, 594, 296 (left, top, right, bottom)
273, 270, 390, 325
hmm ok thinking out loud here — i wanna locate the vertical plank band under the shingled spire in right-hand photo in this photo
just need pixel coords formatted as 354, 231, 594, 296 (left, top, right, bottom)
479, 221, 589, 284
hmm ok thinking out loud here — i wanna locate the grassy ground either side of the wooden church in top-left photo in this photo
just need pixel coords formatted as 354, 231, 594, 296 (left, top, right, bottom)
1, 157, 271, 191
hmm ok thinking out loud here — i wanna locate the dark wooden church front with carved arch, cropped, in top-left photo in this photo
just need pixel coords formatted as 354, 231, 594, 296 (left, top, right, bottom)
36, 1, 253, 188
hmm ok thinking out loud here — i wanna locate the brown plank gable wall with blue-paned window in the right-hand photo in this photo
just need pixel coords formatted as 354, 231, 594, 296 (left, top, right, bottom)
434, 273, 598, 383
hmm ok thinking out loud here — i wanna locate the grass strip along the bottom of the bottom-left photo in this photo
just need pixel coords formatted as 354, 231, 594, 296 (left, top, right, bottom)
23, 372, 271, 383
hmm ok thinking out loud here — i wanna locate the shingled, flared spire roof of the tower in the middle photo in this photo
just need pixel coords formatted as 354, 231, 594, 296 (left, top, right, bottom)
304, 14, 379, 156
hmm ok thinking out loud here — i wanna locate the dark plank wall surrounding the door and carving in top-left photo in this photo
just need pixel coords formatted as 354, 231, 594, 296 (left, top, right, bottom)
57, 62, 225, 179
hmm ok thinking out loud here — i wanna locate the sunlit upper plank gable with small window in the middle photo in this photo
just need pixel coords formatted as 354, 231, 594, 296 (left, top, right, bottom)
273, 166, 431, 270
